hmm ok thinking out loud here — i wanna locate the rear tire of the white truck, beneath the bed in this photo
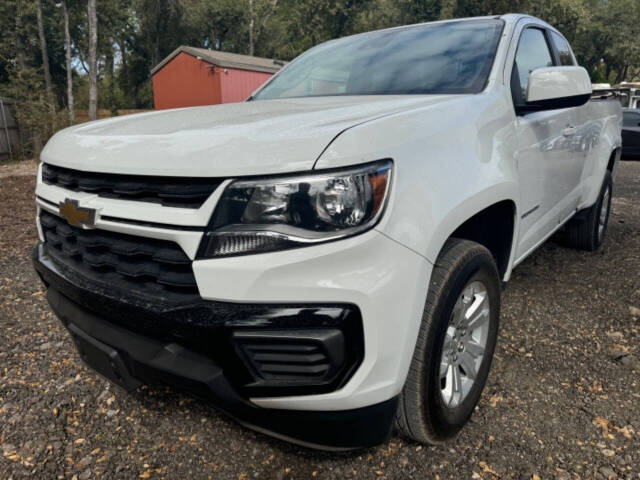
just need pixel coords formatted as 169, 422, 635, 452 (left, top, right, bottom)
560, 171, 613, 252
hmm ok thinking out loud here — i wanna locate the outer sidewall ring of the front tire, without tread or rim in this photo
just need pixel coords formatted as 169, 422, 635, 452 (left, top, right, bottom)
424, 252, 500, 439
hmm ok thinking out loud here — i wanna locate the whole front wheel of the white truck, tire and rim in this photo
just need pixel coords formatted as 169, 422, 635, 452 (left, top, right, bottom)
396, 238, 500, 444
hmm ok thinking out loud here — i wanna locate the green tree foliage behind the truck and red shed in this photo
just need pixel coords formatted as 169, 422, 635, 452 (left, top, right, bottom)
0, 0, 640, 158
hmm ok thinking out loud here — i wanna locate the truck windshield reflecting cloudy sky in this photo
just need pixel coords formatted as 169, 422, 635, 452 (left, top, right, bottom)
254, 19, 503, 100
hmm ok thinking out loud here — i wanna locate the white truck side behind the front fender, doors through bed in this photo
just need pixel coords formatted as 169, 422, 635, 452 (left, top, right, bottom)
503, 17, 621, 264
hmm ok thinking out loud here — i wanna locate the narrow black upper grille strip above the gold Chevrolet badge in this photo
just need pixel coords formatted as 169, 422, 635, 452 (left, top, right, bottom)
42, 163, 222, 208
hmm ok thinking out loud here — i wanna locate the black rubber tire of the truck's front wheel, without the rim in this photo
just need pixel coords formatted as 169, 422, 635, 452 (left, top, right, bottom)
396, 238, 500, 444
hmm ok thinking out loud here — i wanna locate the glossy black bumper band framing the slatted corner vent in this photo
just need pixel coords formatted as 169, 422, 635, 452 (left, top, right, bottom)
33, 243, 364, 397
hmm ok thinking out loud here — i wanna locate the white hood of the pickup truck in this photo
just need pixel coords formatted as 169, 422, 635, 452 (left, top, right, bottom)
41, 95, 456, 177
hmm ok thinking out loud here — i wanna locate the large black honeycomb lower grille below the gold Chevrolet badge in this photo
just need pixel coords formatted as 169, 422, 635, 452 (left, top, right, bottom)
40, 211, 198, 298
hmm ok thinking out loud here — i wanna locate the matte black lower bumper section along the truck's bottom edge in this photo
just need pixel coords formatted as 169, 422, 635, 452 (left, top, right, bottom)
34, 244, 397, 450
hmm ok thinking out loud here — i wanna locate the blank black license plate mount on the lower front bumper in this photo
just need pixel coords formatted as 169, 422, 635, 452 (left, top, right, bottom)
67, 323, 142, 392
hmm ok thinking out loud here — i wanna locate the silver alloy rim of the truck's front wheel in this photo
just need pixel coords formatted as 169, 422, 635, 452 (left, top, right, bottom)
440, 281, 490, 408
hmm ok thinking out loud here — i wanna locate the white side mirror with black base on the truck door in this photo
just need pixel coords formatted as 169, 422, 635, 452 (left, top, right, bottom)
520, 67, 592, 112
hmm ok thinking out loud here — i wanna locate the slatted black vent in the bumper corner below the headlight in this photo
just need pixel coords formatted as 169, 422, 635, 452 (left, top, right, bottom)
233, 328, 345, 387
